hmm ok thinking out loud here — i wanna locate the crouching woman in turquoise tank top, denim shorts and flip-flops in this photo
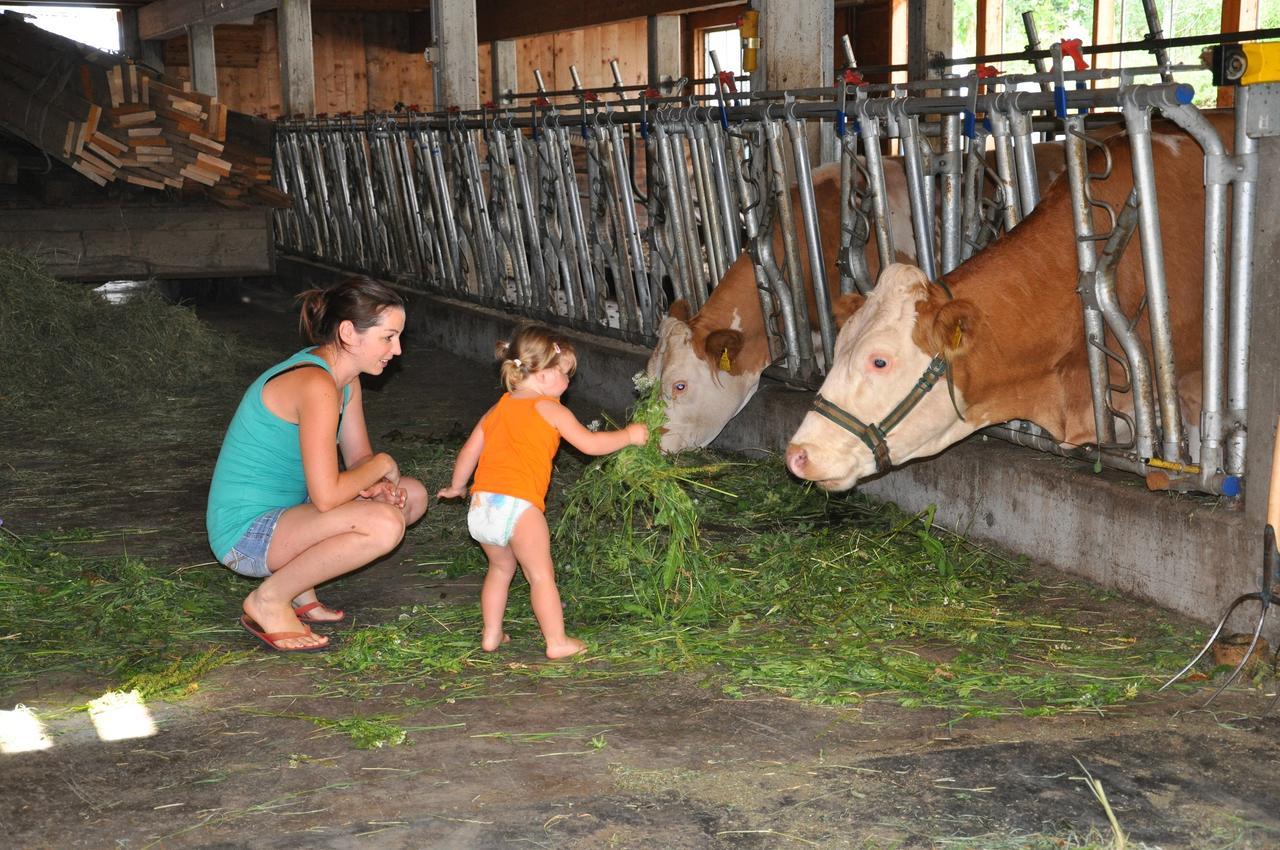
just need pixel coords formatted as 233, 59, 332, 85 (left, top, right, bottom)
206, 277, 428, 652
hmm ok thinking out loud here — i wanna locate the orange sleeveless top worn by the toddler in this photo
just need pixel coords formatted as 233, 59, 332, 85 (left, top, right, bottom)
471, 393, 559, 511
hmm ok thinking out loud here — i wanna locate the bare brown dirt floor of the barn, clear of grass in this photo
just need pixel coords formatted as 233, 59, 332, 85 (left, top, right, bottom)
0, 281, 1280, 850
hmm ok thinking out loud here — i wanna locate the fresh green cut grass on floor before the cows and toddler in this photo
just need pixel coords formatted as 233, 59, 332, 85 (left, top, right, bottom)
326, 381, 1196, 719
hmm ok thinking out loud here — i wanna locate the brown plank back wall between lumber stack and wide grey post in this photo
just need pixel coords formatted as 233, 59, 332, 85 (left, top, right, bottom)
164, 12, 434, 118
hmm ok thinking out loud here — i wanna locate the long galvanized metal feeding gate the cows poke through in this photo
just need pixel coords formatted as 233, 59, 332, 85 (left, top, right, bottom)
275, 6, 1271, 495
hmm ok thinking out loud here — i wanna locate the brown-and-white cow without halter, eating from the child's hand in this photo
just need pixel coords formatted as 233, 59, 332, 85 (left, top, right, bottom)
648, 143, 1064, 452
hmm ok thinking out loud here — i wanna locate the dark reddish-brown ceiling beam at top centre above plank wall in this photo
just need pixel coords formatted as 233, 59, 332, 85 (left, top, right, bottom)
475, 0, 721, 41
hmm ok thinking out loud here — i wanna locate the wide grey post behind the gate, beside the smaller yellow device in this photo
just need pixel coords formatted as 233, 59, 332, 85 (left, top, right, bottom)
751, 0, 836, 165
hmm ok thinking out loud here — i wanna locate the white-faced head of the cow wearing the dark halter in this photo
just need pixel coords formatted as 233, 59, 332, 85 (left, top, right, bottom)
786, 264, 986, 490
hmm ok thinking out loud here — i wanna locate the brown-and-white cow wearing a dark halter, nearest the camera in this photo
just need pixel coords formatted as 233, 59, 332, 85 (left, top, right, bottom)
786, 113, 1233, 490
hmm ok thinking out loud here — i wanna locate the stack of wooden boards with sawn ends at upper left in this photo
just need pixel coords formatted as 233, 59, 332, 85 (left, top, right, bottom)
0, 12, 287, 206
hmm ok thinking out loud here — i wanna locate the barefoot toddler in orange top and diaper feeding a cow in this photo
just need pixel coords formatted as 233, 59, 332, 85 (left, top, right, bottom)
438, 325, 649, 658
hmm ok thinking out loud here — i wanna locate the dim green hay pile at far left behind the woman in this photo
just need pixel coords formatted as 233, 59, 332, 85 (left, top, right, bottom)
0, 250, 243, 426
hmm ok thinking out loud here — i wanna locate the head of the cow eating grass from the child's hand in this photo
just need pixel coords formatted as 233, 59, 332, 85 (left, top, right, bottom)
648, 301, 760, 452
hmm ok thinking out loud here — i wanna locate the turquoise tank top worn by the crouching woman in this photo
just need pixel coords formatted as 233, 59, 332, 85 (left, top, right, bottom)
205, 348, 351, 558
